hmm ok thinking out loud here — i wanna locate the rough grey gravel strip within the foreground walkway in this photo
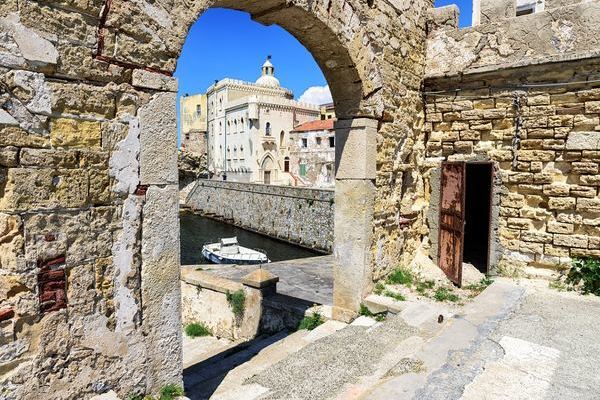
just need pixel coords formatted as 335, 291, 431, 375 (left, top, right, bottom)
246, 317, 416, 400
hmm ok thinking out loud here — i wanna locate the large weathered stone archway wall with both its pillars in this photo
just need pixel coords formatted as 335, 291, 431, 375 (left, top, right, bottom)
0, 0, 433, 398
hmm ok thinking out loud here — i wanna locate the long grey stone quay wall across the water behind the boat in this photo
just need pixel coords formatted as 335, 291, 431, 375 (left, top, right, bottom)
185, 180, 335, 253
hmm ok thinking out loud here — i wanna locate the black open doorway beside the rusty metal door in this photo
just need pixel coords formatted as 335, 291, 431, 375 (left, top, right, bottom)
463, 163, 493, 274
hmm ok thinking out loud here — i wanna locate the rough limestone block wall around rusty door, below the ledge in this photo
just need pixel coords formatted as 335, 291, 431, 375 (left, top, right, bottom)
422, 60, 600, 272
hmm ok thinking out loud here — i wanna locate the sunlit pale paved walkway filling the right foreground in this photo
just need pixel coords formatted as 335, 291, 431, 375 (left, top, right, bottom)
188, 279, 600, 400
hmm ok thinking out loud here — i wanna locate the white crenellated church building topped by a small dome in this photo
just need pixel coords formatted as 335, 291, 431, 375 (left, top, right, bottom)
206, 56, 320, 186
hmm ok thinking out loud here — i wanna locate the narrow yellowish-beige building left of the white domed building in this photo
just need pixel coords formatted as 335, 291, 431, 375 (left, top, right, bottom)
179, 94, 207, 156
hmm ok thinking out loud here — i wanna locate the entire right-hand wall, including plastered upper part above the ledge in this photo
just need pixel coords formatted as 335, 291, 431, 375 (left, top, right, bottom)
420, 0, 600, 274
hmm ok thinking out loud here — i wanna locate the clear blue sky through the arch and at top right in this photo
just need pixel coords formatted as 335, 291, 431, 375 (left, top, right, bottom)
175, 0, 472, 136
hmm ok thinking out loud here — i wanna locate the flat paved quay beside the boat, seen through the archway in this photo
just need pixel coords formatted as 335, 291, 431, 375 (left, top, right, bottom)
200, 255, 333, 305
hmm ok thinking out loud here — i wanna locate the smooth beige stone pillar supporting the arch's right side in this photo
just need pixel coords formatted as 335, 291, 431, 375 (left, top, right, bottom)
333, 118, 378, 321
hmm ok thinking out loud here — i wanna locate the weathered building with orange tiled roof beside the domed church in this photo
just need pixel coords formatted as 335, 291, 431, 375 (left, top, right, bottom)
289, 119, 335, 187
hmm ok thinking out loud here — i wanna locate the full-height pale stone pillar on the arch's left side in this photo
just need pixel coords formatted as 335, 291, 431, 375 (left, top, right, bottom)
137, 86, 183, 393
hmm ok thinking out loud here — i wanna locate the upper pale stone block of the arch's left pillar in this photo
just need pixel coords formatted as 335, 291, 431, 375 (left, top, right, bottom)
138, 93, 177, 185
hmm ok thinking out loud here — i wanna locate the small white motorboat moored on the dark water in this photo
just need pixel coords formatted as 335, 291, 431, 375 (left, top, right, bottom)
202, 237, 271, 264
